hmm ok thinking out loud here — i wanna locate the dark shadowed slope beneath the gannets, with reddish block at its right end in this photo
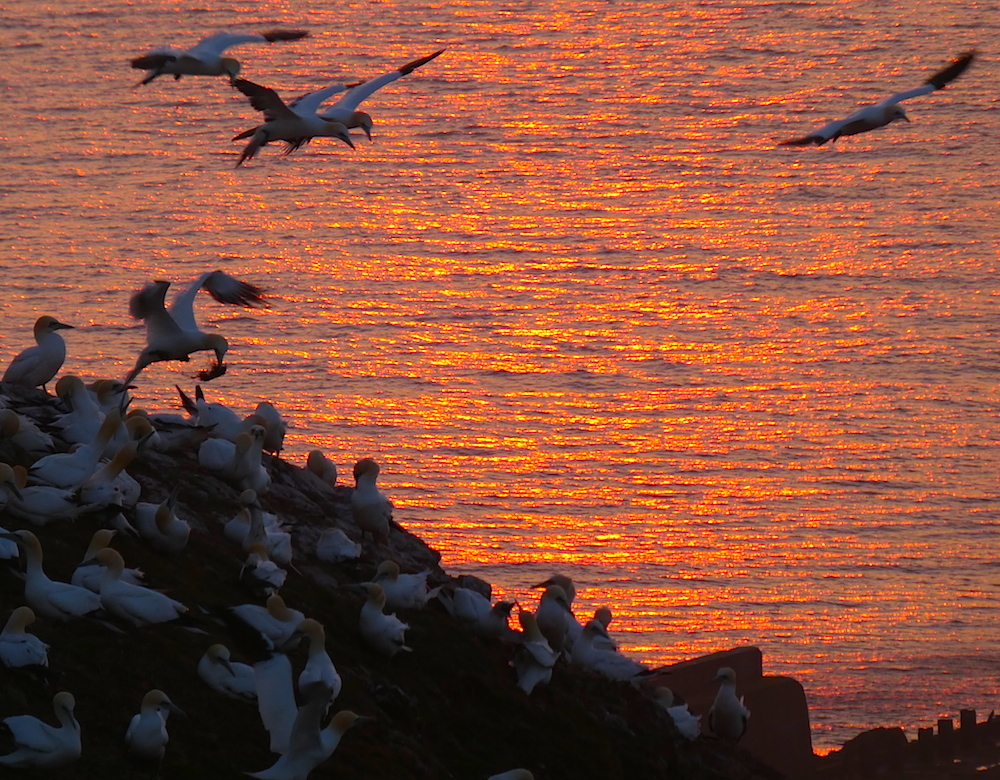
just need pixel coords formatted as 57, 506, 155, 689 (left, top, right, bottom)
0, 386, 796, 780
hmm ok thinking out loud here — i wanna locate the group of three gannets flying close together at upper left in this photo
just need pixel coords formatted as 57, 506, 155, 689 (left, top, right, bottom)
124, 29, 444, 168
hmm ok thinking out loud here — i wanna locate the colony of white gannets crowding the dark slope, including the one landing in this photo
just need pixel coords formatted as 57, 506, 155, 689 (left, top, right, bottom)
0, 278, 749, 780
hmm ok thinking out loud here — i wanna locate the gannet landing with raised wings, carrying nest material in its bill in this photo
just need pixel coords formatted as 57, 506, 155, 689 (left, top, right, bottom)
124, 271, 263, 385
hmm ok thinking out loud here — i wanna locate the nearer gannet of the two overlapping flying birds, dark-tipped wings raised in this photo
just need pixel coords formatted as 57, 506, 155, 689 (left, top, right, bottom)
233, 79, 354, 168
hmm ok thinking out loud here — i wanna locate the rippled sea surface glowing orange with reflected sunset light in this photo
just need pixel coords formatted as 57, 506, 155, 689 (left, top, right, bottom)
0, 0, 1000, 749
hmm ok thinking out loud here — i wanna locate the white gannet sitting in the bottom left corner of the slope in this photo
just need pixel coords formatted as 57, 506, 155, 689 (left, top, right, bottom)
0, 691, 81, 769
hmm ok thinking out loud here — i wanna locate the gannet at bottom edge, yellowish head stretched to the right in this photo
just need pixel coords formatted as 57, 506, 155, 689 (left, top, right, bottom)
248, 683, 370, 780
